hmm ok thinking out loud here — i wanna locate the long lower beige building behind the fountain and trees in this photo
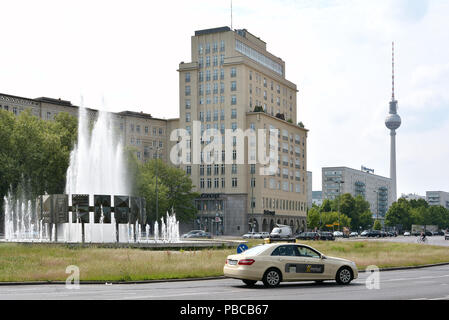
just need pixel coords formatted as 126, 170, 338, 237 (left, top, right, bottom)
0, 94, 173, 161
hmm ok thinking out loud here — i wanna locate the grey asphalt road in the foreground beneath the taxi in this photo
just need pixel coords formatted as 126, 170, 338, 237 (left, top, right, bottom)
0, 266, 449, 300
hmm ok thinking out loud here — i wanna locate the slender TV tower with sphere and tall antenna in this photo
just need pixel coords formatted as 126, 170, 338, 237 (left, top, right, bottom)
385, 42, 401, 201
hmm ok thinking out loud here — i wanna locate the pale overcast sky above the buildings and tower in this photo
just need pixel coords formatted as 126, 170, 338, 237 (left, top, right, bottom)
0, 0, 449, 195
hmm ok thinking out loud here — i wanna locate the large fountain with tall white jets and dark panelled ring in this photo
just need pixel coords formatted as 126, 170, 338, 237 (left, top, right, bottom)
5, 108, 179, 243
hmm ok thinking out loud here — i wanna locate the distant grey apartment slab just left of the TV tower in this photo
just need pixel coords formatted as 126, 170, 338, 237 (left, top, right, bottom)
322, 167, 395, 219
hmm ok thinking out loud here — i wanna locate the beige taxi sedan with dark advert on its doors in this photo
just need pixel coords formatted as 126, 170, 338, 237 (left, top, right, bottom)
223, 243, 358, 287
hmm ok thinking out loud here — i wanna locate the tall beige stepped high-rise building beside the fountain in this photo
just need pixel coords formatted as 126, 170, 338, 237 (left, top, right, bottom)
178, 27, 307, 235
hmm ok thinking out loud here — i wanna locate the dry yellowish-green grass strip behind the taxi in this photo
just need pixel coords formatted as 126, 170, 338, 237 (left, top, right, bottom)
0, 240, 449, 282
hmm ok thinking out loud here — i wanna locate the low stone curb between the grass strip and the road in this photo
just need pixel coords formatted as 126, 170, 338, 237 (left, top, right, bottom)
0, 262, 449, 287
